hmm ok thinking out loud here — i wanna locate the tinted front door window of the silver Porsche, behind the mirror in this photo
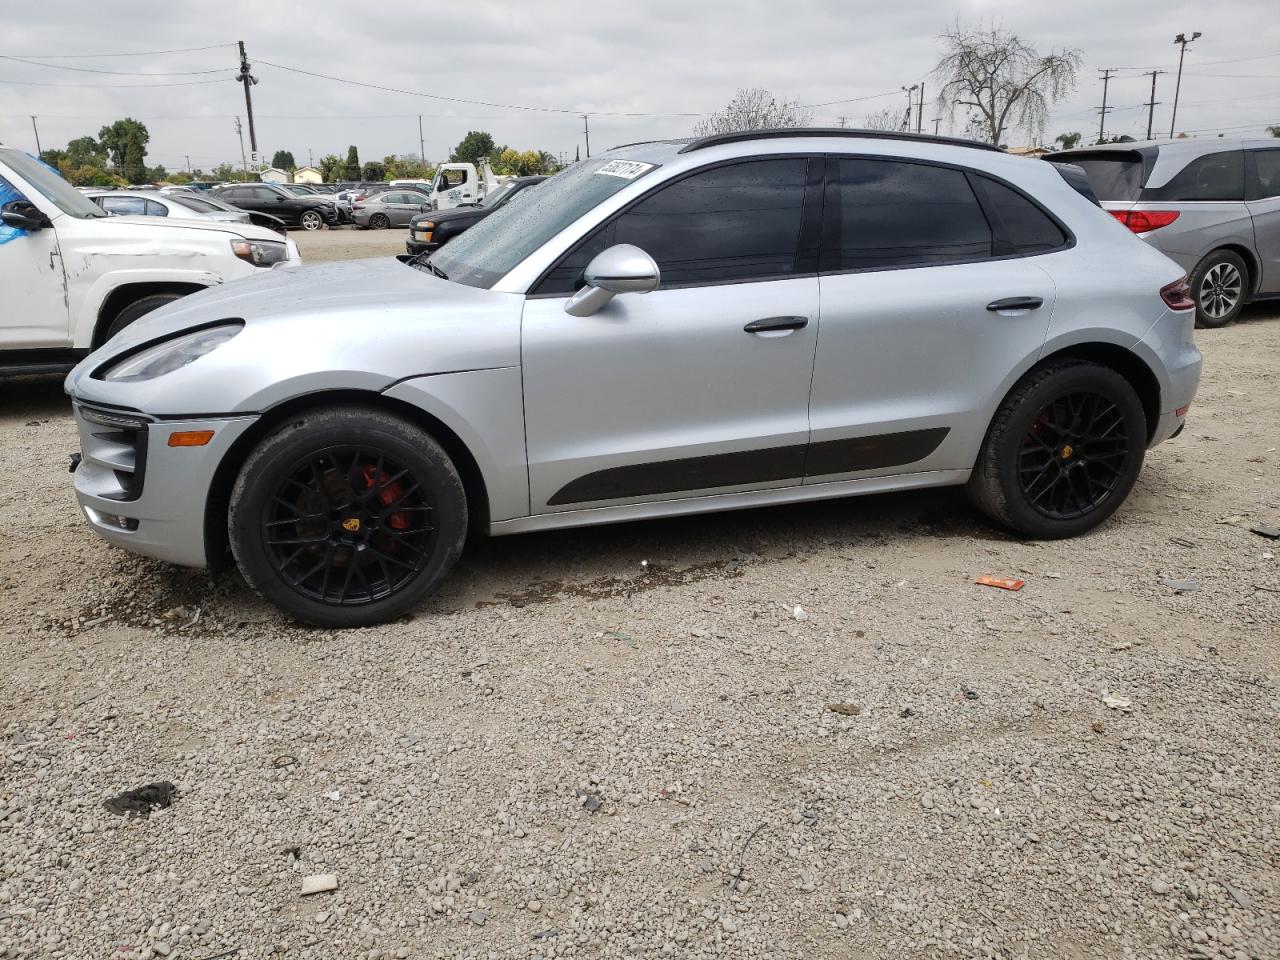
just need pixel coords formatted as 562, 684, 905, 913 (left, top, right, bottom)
613, 157, 808, 287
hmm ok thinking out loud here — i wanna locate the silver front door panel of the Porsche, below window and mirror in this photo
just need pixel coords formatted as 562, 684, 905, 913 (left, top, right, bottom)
522, 276, 818, 513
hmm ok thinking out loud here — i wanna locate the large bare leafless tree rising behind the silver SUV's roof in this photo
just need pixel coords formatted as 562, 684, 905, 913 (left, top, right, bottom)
934, 23, 1083, 143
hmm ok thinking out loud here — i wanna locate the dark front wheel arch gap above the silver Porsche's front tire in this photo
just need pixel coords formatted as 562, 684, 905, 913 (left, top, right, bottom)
205, 390, 489, 572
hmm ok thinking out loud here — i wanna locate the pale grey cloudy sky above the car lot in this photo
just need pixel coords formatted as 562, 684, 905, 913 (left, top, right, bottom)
0, 0, 1280, 169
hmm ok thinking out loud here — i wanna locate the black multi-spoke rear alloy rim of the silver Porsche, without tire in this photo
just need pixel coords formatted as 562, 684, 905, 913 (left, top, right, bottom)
1018, 392, 1133, 520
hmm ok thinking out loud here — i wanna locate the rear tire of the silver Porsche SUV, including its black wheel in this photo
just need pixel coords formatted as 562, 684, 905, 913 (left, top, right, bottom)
968, 361, 1147, 540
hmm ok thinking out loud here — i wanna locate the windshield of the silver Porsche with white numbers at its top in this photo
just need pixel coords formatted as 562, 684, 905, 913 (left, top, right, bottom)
426, 160, 654, 288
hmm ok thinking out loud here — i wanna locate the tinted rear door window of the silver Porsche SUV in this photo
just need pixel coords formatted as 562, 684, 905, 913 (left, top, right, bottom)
820, 159, 992, 271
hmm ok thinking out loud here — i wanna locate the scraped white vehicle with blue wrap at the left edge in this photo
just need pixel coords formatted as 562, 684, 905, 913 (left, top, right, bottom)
0, 145, 300, 375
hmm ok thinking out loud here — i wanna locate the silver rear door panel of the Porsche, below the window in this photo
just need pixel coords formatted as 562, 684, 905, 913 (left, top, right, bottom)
805, 259, 1055, 483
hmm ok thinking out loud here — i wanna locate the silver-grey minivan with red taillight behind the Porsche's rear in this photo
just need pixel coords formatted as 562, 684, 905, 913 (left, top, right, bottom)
1046, 140, 1280, 326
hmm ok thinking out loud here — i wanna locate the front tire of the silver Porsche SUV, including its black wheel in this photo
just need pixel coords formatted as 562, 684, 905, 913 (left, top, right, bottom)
227, 407, 467, 627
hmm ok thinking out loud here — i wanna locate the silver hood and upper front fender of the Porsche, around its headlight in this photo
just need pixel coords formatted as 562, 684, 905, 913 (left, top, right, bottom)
67, 259, 525, 416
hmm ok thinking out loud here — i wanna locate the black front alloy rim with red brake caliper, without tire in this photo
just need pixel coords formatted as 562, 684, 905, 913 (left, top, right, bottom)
261, 447, 435, 607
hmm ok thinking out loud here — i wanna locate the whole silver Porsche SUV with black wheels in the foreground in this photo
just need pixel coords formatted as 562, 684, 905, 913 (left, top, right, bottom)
67, 129, 1201, 626
